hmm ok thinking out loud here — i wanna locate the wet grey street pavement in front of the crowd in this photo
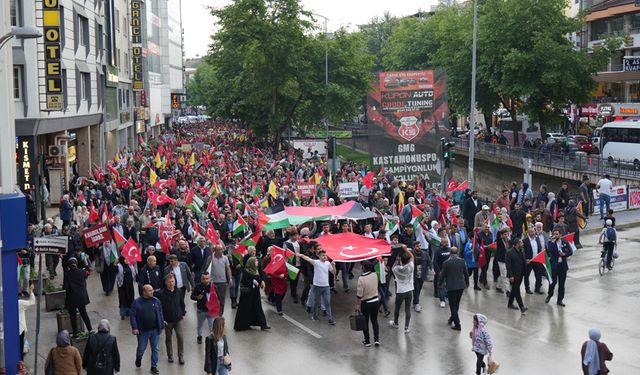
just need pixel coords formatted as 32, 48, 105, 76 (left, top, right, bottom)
26, 228, 640, 375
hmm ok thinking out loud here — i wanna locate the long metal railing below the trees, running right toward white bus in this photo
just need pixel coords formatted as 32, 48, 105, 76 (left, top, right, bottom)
453, 138, 640, 179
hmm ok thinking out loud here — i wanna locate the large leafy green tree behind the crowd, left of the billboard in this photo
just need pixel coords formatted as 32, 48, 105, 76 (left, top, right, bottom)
190, 0, 373, 145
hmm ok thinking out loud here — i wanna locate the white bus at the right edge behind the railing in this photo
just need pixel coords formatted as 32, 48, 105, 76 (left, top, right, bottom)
600, 119, 640, 170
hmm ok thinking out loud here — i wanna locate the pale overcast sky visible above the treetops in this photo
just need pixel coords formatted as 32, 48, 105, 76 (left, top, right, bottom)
182, 0, 437, 58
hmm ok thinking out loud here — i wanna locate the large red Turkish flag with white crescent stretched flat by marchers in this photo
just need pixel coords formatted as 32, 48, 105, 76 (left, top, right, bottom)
316, 232, 391, 262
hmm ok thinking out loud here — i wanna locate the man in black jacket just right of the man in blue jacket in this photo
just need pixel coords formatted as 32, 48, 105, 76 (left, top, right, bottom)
153, 273, 187, 365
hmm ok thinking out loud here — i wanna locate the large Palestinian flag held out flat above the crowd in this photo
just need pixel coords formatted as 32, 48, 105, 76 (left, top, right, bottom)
263, 201, 377, 230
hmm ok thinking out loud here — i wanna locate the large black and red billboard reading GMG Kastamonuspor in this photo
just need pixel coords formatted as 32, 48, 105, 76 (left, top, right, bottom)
367, 70, 449, 187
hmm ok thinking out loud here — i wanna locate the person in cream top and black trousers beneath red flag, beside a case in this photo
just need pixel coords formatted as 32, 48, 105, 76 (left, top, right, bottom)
356, 260, 380, 347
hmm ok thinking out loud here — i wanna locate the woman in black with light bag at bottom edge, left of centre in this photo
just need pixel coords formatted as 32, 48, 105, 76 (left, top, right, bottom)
204, 317, 231, 375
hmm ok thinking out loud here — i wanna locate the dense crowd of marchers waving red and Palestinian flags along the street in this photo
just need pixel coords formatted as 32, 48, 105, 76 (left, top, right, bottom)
19, 122, 615, 375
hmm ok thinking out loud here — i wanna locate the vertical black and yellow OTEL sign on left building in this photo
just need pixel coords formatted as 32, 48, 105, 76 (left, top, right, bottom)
42, 0, 64, 111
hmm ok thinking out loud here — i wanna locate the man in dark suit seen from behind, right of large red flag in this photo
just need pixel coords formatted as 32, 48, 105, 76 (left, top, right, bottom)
440, 247, 469, 331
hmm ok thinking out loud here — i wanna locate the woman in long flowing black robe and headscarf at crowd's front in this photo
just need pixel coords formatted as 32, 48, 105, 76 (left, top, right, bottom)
233, 256, 271, 331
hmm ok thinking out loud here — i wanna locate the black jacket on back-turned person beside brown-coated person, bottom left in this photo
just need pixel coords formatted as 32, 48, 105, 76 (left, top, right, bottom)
82, 332, 120, 375
